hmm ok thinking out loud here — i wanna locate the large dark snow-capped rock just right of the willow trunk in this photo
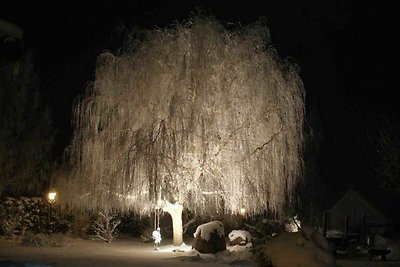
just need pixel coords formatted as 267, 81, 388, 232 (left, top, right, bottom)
192, 221, 226, 254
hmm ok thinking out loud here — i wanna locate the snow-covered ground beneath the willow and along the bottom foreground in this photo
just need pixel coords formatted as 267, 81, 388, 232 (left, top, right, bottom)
0, 238, 400, 267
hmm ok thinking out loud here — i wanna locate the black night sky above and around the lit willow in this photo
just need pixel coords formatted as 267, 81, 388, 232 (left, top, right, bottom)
0, 0, 400, 213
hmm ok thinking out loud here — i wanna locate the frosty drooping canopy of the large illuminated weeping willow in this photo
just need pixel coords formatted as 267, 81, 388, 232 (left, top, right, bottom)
60, 17, 304, 246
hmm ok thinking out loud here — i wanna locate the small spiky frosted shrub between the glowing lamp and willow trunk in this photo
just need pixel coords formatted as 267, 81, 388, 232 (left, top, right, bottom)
92, 212, 121, 243
